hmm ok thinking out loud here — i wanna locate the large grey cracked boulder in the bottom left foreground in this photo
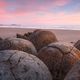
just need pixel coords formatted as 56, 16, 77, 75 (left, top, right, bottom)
0, 50, 52, 80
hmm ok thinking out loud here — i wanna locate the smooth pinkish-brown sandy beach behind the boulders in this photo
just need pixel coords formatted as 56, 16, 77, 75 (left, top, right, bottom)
0, 28, 80, 42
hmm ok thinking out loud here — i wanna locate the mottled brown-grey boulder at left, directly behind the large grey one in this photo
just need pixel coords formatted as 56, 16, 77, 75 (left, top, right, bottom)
0, 38, 37, 55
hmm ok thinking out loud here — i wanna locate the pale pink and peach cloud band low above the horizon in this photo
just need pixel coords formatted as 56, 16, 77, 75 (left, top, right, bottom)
0, 12, 80, 25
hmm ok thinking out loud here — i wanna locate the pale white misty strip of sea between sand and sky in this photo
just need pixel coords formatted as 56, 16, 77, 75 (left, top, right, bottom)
0, 24, 80, 30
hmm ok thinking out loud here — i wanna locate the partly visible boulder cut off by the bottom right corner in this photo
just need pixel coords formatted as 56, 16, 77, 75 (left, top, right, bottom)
64, 60, 80, 80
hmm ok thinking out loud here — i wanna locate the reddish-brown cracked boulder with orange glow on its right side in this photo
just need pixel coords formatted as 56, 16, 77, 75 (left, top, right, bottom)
38, 42, 80, 80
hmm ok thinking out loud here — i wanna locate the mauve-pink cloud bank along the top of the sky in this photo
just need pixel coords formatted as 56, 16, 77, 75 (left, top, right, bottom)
0, 0, 70, 13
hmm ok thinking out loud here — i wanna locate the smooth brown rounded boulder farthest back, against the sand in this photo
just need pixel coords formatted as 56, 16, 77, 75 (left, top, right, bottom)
29, 30, 58, 51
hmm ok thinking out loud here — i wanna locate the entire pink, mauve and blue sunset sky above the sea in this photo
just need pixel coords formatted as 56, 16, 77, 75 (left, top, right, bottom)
0, 0, 80, 25
